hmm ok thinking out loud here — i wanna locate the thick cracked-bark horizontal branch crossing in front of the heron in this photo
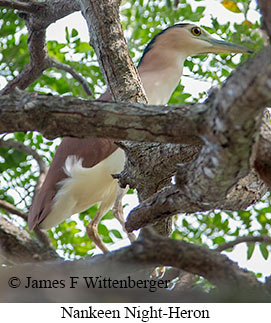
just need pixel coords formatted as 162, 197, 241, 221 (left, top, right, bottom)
0, 91, 204, 144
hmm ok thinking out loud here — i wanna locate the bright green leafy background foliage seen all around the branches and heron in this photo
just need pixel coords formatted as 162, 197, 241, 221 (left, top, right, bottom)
0, 0, 271, 274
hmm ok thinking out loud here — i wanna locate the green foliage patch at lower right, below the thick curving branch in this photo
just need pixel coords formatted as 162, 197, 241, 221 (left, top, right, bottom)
172, 196, 271, 259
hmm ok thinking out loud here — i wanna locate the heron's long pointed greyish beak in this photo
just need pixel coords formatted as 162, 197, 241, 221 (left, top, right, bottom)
204, 37, 253, 54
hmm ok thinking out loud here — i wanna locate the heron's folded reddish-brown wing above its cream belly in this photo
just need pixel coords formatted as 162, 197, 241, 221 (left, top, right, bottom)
28, 91, 118, 230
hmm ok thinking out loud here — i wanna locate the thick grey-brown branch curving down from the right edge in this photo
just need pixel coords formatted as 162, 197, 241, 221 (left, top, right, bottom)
176, 47, 271, 203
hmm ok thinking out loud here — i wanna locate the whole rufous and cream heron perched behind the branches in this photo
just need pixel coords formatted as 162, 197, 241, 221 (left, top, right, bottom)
28, 23, 252, 252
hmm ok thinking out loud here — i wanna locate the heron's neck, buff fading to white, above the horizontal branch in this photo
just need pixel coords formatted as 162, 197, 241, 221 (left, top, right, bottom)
138, 49, 186, 105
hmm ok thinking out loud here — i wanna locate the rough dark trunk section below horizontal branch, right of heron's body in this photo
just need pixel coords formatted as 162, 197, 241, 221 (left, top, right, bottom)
114, 142, 202, 202
